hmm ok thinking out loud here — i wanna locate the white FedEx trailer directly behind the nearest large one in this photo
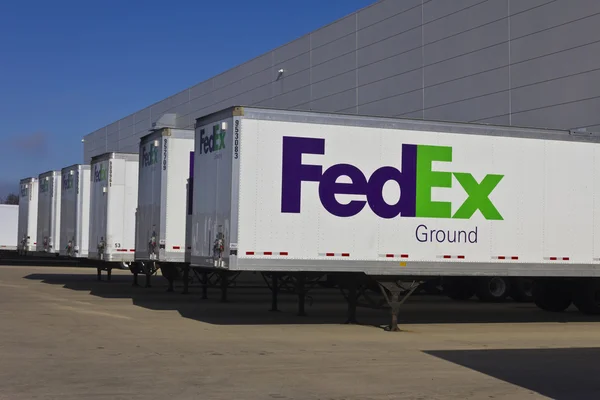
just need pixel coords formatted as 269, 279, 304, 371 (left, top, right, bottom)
135, 127, 194, 290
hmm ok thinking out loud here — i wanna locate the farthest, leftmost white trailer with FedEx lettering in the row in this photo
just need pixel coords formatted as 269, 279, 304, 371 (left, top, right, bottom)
17, 178, 38, 254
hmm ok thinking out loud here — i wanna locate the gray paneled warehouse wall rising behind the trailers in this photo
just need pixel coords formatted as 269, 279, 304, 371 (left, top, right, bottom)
84, 0, 600, 162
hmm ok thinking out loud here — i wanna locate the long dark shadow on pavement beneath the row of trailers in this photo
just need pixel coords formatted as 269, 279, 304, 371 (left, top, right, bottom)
24, 269, 600, 327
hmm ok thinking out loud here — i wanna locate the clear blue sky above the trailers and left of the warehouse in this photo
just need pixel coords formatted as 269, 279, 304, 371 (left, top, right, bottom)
0, 0, 375, 197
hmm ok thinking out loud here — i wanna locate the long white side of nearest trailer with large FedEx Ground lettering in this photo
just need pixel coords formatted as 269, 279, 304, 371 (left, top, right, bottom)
229, 110, 600, 276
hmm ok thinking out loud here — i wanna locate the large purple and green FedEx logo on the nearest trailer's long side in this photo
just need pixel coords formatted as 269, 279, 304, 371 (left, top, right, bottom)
281, 137, 504, 220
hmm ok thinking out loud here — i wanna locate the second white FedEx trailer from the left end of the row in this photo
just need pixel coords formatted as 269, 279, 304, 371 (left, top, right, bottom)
36, 171, 62, 255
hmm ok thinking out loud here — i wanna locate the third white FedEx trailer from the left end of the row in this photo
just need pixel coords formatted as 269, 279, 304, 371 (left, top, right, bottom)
60, 164, 90, 258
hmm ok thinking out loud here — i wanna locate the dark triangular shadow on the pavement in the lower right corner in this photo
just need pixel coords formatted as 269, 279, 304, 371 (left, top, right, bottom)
425, 348, 600, 400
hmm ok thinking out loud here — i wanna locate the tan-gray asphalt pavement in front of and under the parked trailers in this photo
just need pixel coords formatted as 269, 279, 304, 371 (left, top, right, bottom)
0, 266, 600, 400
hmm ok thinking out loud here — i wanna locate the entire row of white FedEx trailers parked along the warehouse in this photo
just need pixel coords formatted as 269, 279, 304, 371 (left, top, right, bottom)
11, 107, 600, 328
